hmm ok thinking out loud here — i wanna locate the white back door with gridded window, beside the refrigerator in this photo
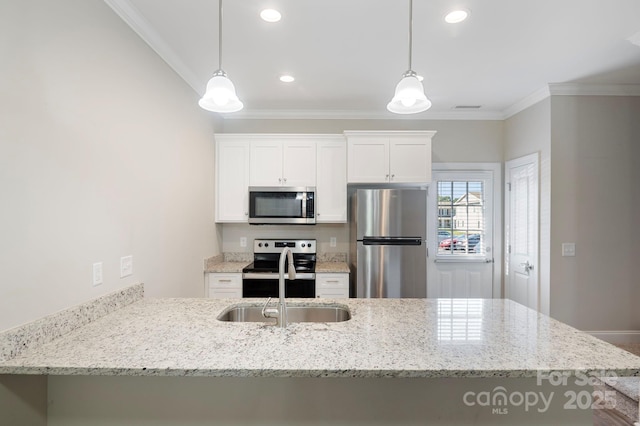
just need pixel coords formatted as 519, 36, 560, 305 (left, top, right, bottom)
427, 164, 500, 298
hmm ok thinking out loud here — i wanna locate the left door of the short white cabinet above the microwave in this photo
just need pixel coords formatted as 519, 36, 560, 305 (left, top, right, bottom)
249, 139, 282, 186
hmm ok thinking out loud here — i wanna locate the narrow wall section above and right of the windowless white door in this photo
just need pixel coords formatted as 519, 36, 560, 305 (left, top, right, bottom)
504, 98, 551, 315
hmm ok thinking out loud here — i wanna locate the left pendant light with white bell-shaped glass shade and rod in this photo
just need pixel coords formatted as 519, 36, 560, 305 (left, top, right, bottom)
198, 0, 244, 112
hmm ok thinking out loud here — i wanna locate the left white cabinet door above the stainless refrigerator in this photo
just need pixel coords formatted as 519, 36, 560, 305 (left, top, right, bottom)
347, 136, 389, 183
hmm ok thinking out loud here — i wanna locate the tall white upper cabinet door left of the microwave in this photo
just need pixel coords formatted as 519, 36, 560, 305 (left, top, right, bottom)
215, 138, 249, 222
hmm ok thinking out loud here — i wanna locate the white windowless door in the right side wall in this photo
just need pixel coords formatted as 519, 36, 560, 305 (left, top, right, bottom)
505, 154, 540, 310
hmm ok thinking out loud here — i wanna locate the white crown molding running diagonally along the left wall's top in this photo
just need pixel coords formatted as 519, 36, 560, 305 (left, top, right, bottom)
104, 0, 201, 93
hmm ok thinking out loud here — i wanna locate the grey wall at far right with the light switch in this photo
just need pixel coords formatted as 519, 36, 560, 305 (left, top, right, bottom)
551, 96, 640, 334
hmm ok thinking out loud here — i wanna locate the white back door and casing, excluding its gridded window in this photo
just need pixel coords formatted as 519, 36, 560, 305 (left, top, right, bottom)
427, 163, 502, 298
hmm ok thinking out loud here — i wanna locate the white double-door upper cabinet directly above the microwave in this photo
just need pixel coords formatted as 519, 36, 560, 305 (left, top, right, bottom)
249, 135, 316, 186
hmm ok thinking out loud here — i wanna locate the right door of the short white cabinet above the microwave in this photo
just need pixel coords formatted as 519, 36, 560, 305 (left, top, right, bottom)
282, 140, 316, 186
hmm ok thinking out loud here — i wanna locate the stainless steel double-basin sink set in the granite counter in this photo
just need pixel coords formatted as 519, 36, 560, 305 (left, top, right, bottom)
217, 304, 351, 324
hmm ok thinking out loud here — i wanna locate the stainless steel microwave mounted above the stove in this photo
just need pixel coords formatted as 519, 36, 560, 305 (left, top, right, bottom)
249, 186, 316, 225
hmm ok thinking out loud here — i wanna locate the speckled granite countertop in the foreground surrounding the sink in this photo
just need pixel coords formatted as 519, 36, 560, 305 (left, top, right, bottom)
0, 299, 640, 377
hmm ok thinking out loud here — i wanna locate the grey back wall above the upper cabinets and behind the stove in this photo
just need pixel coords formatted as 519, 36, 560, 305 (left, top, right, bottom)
221, 118, 504, 253
